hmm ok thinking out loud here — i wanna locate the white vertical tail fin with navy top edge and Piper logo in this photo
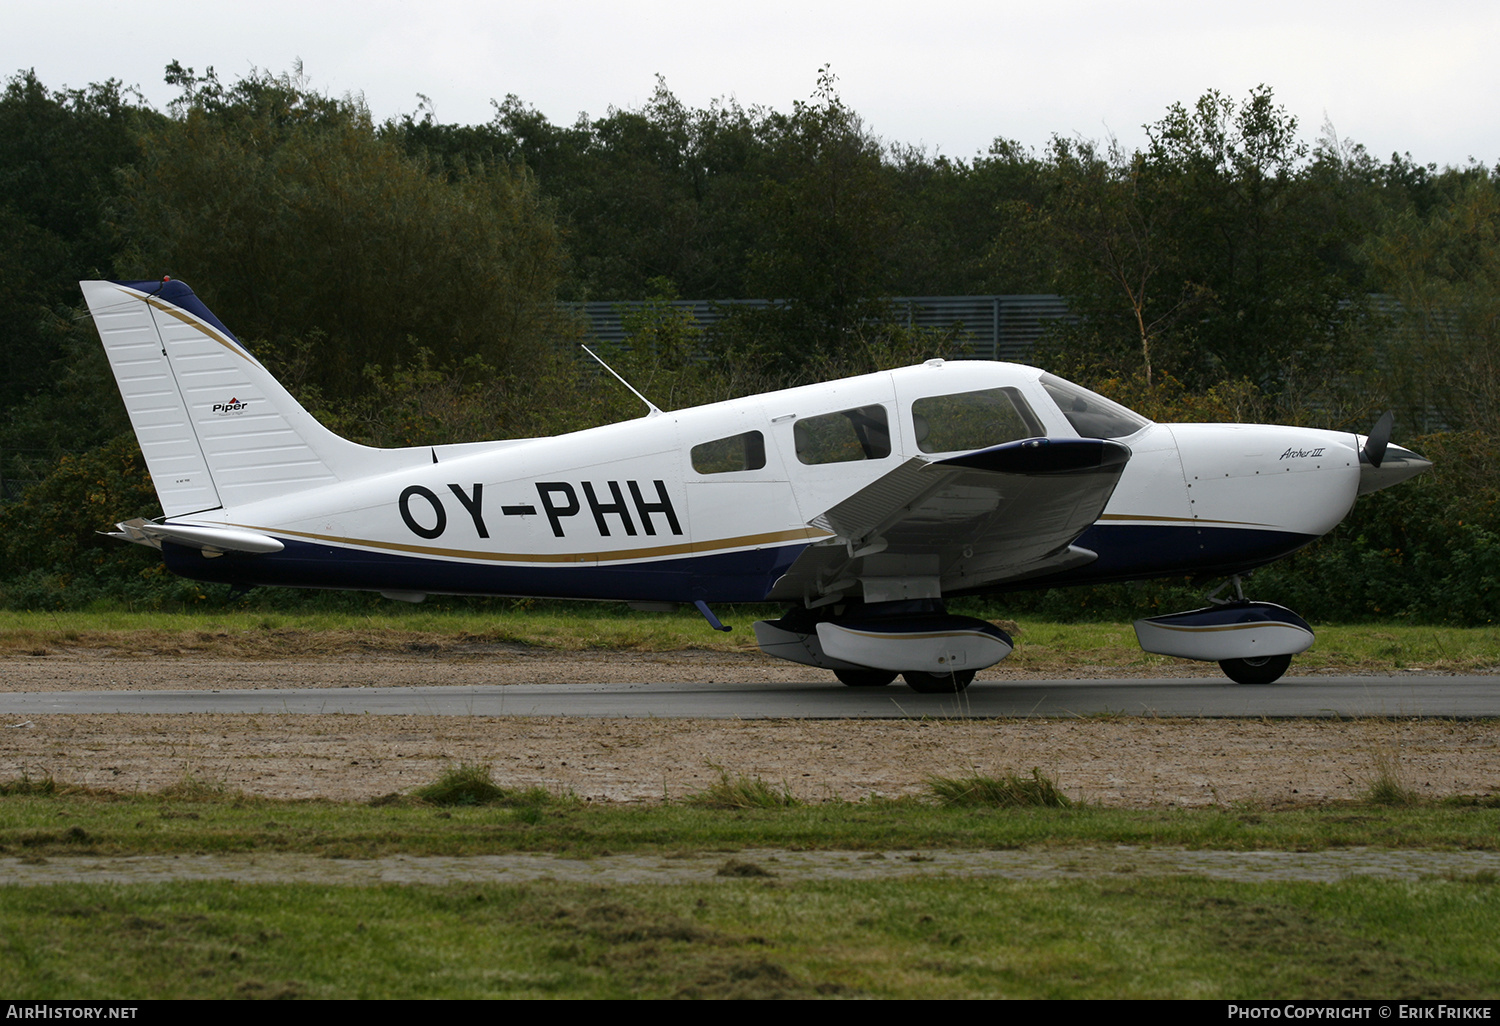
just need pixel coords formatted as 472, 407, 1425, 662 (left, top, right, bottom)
80, 279, 410, 516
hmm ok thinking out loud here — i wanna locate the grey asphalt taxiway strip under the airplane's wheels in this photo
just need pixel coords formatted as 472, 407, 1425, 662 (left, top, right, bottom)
0, 674, 1500, 720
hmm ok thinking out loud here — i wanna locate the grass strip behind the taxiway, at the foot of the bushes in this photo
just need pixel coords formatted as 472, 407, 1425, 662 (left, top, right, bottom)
0, 602, 1500, 677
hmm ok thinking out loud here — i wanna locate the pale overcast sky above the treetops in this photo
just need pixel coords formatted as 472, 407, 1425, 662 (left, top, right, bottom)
11, 0, 1500, 165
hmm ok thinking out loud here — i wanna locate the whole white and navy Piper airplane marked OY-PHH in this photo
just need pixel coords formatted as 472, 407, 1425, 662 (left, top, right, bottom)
81, 279, 1431, 692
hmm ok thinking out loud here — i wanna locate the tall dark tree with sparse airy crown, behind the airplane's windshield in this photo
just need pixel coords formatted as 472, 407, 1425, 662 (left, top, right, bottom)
992, 86, 1368, 401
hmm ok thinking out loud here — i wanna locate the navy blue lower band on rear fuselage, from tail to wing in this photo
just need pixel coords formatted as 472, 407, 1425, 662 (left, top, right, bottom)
162, 539, 807, 602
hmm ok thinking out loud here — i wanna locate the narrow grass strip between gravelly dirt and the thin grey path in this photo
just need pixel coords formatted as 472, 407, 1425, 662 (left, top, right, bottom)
0, 789, 1500, 858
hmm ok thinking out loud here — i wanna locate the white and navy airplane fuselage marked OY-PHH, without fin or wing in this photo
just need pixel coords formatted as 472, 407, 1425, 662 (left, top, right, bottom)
164, 362, 1362, 602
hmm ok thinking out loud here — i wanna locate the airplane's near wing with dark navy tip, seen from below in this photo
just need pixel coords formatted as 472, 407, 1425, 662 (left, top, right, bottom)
770, 438, 1130, 606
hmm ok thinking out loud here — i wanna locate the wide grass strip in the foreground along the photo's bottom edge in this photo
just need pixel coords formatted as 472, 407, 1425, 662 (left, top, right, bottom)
0, 876, 1500, 1001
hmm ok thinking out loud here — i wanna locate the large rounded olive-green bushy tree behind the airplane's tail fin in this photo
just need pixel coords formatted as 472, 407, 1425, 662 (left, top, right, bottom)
122, 65, 563, 390
